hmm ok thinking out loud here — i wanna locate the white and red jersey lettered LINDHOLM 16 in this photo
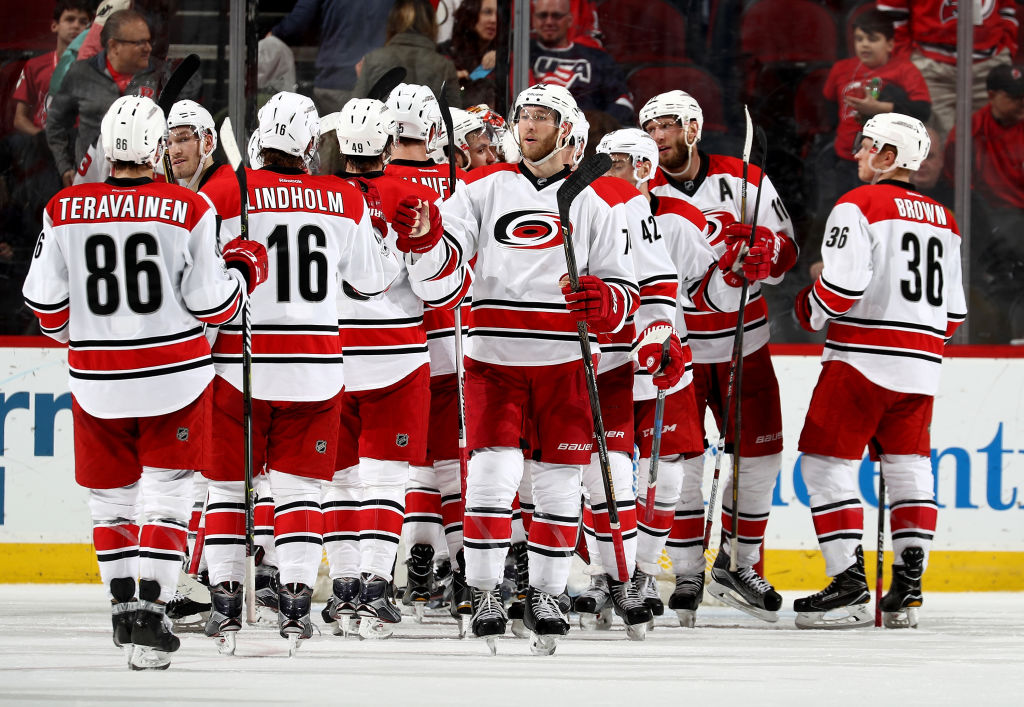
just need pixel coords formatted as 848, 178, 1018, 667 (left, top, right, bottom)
203, 161, 401, 401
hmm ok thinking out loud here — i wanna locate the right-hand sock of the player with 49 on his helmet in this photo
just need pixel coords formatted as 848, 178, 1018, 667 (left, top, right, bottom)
359, 457, 407, 580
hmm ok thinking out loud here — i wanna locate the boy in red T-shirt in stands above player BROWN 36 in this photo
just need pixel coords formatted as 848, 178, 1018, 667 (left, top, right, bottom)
816, 10, 931, 213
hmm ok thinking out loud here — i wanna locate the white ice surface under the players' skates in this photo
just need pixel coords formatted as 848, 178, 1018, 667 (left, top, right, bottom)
0, 585, 1024, 707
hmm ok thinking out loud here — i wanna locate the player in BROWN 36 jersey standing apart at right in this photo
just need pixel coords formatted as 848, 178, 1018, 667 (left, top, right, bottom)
794, 113, 967, 628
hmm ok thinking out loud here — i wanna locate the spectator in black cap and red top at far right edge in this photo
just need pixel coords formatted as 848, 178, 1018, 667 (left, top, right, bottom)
944, 66, 1024, 343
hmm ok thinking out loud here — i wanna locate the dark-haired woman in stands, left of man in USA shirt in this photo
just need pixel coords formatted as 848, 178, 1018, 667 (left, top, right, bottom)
437, 0, 498, 106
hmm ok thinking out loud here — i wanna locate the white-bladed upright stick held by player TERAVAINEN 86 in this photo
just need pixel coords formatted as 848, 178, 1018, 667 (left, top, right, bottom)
220, 118, 256, 624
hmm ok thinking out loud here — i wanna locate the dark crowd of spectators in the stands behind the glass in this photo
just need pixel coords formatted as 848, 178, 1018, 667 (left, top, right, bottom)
0, 0, 1024, 344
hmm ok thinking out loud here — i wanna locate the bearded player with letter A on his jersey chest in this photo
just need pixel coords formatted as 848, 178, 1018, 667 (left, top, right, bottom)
640, 90, 797, 621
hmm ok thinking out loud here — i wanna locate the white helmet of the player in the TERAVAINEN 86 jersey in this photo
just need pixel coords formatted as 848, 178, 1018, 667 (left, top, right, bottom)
99, 95, 167, 168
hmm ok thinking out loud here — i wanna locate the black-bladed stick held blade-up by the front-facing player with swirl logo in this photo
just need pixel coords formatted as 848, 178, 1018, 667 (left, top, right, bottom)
556, 153, 630, 582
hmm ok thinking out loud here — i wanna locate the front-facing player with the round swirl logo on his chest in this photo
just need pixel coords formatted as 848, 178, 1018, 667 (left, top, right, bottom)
409, 85, 638, 653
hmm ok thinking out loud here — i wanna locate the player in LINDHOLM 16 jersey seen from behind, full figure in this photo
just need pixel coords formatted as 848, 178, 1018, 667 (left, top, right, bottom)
197, 92, 399, 652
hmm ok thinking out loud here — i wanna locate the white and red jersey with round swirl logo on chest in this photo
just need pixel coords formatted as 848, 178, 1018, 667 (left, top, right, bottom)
418, 163, 639, 366
